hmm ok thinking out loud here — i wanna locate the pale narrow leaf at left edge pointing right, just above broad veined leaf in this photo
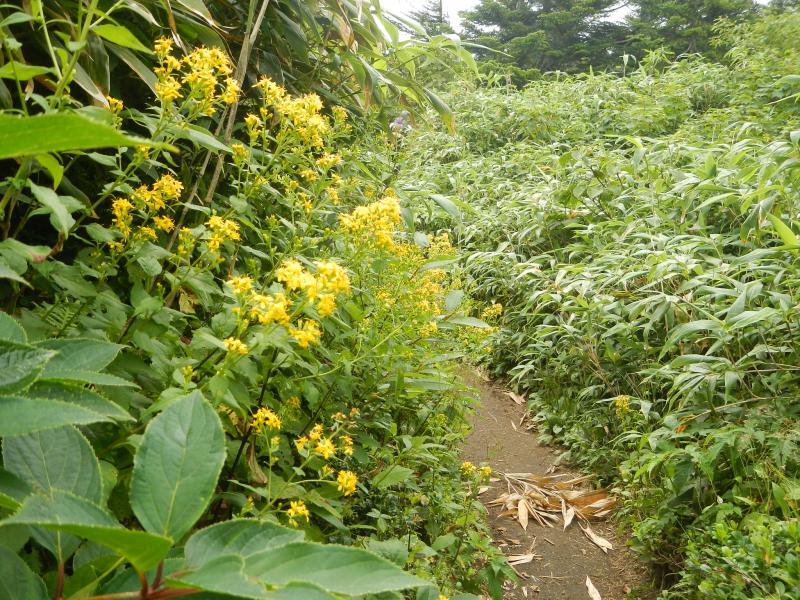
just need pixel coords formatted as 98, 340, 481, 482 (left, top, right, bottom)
0, 396, 111, 437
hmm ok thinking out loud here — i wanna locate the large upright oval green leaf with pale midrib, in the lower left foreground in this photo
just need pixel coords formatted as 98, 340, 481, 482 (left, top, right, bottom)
131, 393, 225, 540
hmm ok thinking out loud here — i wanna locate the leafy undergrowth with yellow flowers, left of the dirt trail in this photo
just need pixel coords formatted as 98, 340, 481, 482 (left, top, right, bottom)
0, 0, 508, 600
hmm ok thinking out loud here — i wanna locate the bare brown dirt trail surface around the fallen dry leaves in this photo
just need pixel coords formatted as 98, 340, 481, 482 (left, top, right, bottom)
463, 369, 653, 600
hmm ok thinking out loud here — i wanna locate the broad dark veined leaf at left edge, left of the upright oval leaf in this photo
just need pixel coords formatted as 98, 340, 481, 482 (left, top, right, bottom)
3, 427, 102, 502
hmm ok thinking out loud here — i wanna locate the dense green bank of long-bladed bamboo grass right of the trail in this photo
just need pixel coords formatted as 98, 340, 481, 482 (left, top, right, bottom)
400, 14, 800, 598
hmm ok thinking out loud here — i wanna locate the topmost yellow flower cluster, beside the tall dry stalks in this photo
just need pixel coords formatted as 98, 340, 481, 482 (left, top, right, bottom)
154, 37, 240, 116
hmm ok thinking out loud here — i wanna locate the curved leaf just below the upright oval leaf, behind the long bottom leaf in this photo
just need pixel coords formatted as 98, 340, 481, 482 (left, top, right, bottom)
184, 519, 303, 568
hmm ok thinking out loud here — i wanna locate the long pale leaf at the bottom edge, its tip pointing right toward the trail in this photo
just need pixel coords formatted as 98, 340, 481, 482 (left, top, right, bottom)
245, 542, 427, 596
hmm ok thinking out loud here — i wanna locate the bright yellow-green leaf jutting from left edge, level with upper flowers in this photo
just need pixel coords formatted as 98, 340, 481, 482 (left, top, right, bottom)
0, 112, 152, 159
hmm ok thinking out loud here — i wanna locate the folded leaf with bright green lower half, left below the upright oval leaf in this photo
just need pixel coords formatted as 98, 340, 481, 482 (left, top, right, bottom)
0, 491, 172, 571
